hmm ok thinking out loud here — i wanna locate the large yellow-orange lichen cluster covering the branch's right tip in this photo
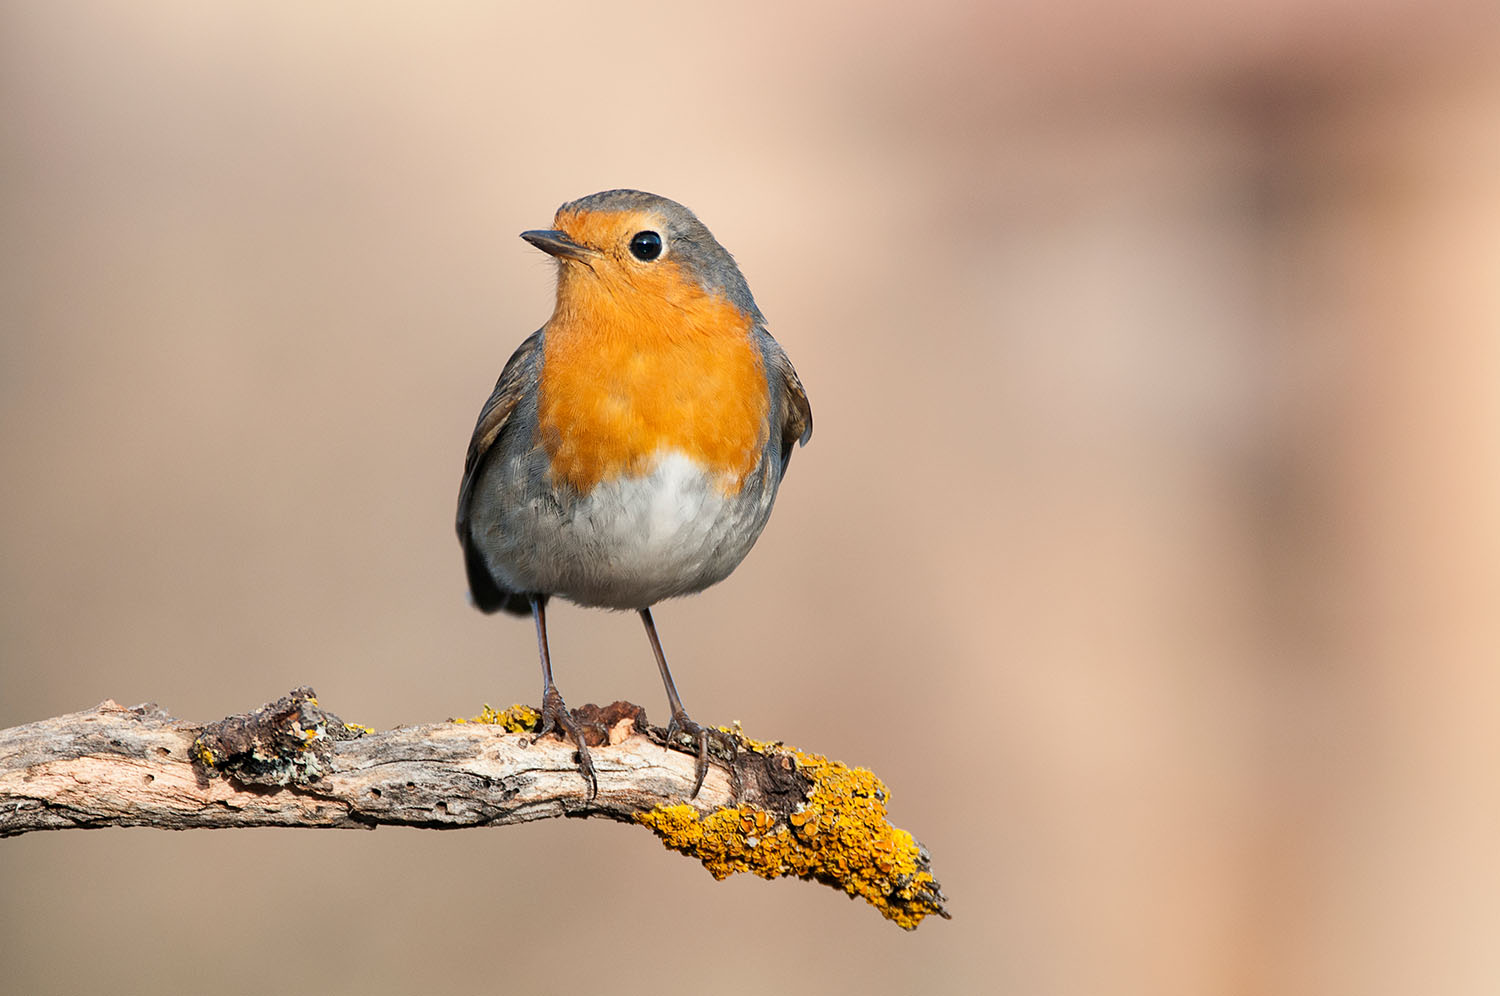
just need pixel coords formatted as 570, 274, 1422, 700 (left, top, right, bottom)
636, 731, 947, 930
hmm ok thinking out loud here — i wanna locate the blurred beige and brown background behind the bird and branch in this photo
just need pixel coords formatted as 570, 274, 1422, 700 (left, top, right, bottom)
0, 0, 1500, 996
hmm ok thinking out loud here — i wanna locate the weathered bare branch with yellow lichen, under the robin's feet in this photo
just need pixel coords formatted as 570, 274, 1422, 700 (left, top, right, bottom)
0, 689, 948, 930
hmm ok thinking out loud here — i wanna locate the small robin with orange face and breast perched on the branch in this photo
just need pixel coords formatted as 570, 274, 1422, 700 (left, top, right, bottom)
458, 191, 813, 797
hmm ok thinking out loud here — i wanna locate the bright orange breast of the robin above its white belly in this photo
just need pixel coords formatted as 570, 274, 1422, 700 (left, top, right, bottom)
537, 261, 770, 494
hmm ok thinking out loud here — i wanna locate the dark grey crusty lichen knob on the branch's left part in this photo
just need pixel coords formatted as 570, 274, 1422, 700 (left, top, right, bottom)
192, 686, 374, 786
